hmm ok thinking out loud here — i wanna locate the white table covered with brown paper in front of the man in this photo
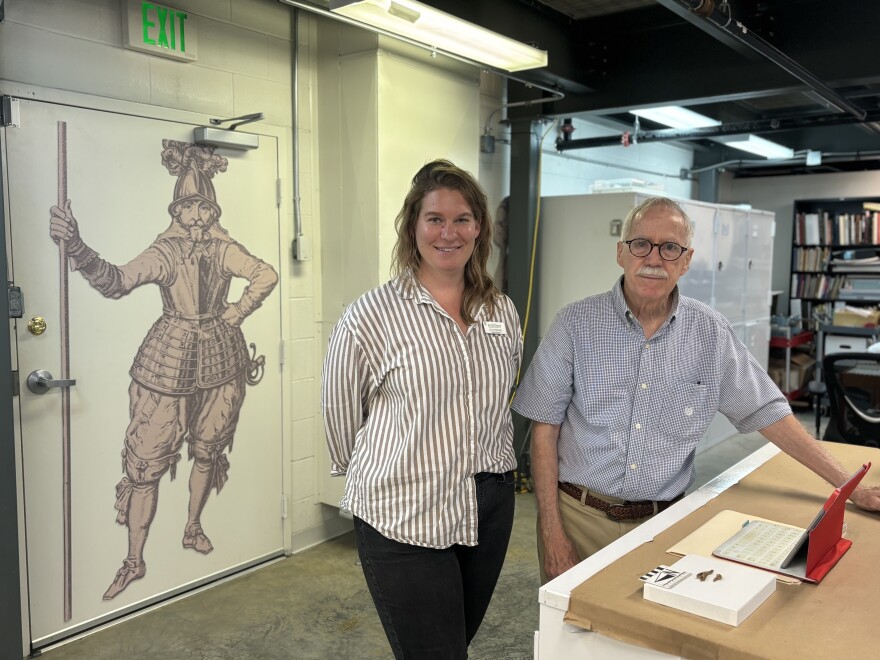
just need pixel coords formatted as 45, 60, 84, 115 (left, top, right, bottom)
535, 443, 880, 660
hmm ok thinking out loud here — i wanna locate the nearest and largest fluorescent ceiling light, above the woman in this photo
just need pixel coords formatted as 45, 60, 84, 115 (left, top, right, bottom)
330, 0, 547, 71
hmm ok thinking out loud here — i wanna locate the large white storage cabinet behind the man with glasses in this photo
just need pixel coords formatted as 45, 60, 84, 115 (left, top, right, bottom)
537, 192, 775, 449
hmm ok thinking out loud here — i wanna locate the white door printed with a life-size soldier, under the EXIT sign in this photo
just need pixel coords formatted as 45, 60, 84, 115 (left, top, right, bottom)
0, 100, 284, 648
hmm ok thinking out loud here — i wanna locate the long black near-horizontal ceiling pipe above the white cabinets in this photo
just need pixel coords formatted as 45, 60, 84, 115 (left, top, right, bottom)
556, 110, 880, 151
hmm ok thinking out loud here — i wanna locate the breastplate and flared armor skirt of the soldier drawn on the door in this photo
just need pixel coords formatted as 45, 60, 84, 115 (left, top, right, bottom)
130, 239, 249, 395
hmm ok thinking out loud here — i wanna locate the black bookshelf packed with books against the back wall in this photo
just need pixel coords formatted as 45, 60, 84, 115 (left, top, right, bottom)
790, 197, 880, 332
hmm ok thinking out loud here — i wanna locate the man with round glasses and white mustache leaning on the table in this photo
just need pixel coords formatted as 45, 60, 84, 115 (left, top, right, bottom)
513, 197, 880, 581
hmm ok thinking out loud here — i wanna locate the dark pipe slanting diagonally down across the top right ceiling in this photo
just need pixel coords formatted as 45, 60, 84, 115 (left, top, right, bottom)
657, 0, 866, 121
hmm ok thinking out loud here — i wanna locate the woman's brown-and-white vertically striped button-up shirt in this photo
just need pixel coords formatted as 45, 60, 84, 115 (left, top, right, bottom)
321, 273, 522, 548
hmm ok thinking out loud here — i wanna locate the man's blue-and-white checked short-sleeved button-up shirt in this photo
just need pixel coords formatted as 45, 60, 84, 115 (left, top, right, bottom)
513, 278, 791, 501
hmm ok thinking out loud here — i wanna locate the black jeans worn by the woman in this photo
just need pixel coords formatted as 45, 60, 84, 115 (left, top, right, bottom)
354, 472, 514, 660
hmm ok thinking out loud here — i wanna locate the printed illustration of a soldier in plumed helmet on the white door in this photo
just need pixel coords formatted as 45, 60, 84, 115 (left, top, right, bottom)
49, 140, 278, 600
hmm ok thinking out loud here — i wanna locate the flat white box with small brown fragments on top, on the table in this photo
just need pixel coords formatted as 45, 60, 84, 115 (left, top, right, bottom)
641, 555, 776, 626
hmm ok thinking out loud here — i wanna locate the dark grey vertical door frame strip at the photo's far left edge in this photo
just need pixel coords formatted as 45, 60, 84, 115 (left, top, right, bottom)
0, 120, 25, 658
